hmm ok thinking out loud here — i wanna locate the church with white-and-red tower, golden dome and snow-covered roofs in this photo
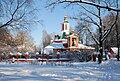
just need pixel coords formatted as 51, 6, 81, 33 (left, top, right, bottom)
45, 16, 95, 53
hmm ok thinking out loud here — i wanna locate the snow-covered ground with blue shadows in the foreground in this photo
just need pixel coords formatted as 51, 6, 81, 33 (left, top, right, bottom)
0, 60, 120, 81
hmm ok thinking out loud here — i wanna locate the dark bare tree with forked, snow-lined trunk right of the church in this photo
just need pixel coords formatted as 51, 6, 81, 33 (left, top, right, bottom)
48, 0, 120, 63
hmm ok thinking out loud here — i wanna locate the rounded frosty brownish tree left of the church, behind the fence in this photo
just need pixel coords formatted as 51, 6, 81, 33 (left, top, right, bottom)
13, 31, 35, 53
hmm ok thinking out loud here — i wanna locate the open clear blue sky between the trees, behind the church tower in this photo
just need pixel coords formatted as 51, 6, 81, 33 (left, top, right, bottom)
32, 1, 76, 46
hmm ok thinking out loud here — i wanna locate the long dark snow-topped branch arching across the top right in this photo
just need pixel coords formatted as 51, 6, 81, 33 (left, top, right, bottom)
47, 0, 120, 11
